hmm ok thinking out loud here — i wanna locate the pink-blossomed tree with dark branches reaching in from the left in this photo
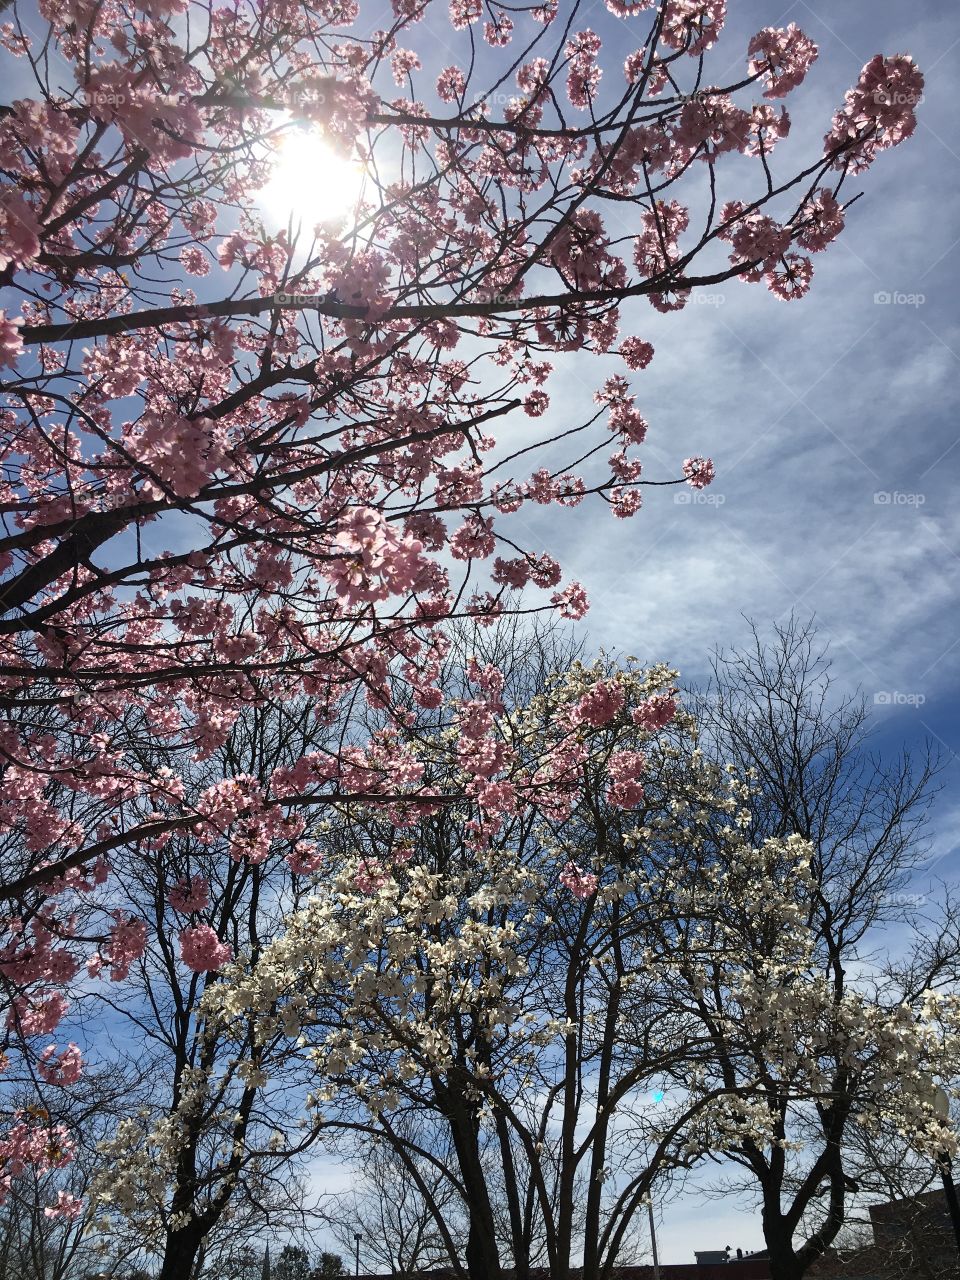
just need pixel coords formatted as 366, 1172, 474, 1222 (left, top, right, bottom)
0, 0, 922, 1208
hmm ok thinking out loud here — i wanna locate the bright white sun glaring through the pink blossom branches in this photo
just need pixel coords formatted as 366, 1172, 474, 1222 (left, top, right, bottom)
260, 129, 364, 230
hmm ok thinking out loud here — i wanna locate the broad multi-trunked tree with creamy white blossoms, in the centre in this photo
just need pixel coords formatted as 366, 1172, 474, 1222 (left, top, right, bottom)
199, 664, 960, 1280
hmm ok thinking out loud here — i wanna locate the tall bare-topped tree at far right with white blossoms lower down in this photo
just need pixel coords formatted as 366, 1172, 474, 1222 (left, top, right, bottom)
627, 617, 960, 1280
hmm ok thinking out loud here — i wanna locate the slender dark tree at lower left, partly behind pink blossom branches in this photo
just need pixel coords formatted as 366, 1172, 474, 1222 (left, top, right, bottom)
81, 699, 337, 1280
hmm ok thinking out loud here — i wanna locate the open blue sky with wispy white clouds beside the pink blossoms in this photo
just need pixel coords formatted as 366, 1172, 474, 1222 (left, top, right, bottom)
317, 0, 960, 1262
